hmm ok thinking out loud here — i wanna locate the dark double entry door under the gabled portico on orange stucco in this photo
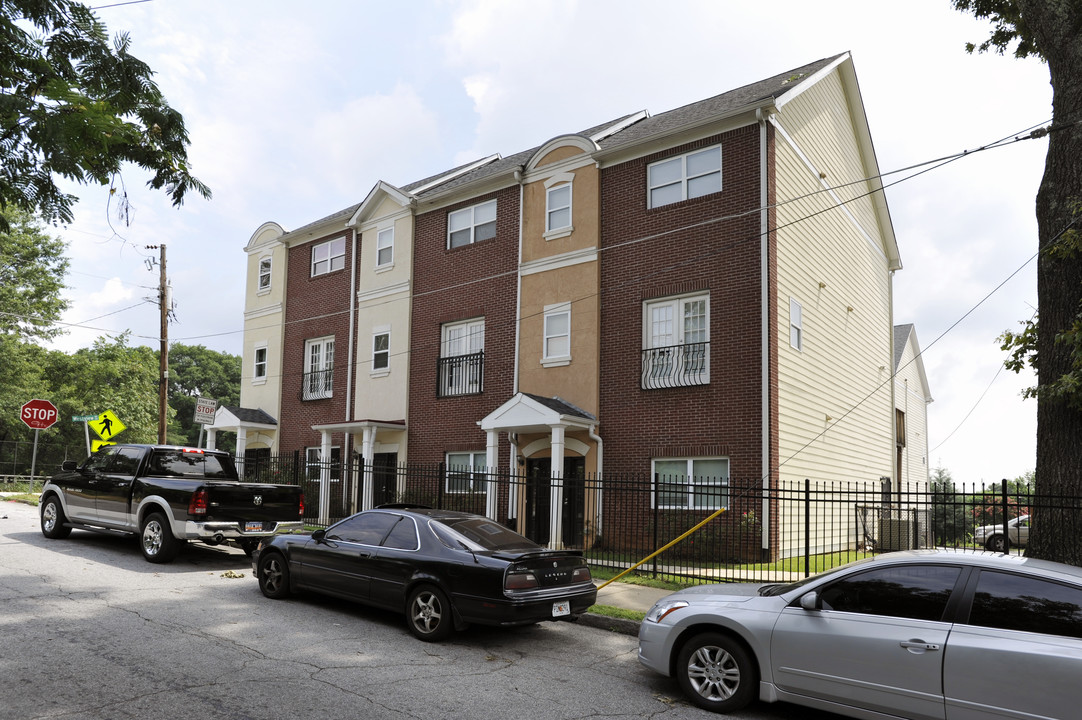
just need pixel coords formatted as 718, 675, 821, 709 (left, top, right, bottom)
526, 457, 586, 547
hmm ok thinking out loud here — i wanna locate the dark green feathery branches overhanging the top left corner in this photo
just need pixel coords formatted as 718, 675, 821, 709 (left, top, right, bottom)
0, 0, 210, 230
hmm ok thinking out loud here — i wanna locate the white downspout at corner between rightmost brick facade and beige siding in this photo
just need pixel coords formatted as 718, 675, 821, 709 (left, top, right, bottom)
755, 107, 771, 548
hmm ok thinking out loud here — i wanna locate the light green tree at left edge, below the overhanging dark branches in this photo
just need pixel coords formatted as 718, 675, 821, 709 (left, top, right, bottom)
0, 208, 68, 340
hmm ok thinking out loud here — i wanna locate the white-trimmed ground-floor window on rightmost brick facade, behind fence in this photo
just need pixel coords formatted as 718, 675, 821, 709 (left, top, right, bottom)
651, 458, 729, 510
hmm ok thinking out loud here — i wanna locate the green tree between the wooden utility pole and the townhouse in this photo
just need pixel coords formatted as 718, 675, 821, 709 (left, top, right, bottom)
169, 343, 240, 449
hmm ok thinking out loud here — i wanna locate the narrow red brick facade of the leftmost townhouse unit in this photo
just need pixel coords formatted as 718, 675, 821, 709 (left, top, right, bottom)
279, 231, 359, 457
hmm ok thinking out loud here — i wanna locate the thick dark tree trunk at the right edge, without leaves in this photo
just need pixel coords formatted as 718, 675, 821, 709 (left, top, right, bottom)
1017, 0, 1082, 566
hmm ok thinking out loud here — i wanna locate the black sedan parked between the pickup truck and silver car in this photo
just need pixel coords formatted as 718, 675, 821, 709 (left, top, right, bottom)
252, 507, 597, 642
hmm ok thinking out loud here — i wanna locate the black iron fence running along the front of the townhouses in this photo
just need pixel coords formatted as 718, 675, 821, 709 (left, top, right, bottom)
242, 453, 1082, 581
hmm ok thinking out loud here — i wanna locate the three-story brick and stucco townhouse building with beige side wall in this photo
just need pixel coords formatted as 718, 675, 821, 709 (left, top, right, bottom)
215, 53, 931, 548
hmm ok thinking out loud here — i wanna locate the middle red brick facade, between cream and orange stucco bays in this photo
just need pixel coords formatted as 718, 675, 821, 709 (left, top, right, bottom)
409, 185, 519, 462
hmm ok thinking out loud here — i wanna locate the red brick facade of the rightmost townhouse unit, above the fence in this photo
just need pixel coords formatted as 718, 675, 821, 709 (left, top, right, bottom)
599, 125, 777, 477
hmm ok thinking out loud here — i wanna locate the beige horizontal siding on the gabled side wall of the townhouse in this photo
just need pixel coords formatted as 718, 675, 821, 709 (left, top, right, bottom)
775, 66, 894, 550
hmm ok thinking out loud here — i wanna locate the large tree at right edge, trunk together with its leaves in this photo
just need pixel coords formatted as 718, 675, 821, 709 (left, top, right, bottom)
952, 0, 1082, 565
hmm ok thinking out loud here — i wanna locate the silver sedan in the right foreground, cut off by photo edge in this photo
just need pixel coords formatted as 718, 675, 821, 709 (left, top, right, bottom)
638, 550, 1082, 720
